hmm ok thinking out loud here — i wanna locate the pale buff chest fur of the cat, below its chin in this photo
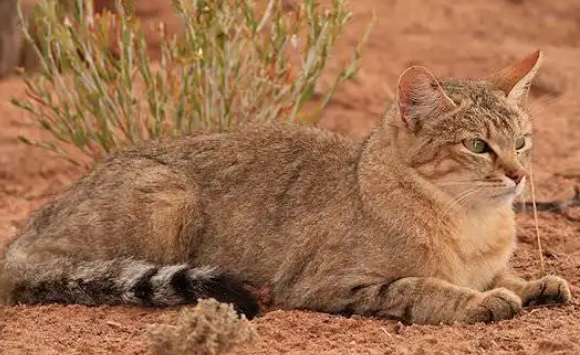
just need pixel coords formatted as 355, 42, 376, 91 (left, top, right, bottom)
448, 212, 515, 290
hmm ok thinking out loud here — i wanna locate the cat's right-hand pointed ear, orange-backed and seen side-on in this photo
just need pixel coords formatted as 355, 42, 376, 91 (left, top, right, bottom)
487, 50, 543, 105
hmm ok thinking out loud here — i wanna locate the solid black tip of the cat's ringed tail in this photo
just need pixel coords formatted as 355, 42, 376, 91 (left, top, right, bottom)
207, 274, 260, 320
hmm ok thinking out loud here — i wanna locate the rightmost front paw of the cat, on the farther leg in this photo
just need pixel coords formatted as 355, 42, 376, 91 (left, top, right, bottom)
524, 275, 572, 306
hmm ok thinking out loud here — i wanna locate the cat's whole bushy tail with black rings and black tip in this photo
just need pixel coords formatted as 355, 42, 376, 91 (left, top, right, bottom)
0, 257, 258, 319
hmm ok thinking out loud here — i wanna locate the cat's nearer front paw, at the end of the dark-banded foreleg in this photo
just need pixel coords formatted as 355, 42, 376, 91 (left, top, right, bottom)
465, 288, 522, 323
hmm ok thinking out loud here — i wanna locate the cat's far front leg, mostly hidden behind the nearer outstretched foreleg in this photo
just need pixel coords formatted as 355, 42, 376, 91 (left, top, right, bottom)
492, 270, 572, 306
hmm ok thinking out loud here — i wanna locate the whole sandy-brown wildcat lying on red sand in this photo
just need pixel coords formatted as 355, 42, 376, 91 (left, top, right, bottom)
0, 51, 571, 323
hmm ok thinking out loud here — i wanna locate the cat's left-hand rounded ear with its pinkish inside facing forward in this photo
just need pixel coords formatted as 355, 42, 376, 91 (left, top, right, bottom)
397, 66, 456, 131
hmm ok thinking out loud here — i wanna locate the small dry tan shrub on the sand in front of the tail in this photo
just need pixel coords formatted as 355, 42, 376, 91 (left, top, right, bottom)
149, 299, 257, 355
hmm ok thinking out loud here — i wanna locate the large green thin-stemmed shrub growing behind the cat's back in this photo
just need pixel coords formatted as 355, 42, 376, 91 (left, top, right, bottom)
13, 0, 370, 167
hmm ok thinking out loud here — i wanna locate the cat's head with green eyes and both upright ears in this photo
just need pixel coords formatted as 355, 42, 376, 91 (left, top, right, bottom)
387, 51, 542, 210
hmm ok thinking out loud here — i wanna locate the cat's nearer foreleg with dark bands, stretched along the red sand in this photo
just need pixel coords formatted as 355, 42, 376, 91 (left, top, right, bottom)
288, 277, 521, 324
